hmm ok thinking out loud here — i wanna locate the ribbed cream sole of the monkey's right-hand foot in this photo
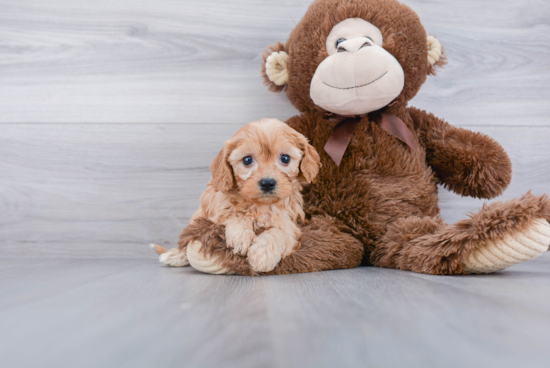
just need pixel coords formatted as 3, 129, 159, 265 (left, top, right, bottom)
463, 219, 550, 273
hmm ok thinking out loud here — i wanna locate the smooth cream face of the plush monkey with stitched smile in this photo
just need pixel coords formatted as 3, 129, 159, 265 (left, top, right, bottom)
310, 18, 405, 115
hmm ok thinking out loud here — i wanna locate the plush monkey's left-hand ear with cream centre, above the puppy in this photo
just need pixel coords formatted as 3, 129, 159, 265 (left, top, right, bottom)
262, 42, 288, 92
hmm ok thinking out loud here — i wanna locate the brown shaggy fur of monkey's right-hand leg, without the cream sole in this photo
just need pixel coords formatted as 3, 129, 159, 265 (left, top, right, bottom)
371, 193, 550, 275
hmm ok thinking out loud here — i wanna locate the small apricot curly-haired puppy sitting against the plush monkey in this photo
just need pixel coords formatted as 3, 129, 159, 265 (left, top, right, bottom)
153, 119, 320, 272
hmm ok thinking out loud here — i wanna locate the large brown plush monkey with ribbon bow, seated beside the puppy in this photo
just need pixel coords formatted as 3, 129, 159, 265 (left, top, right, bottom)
179, 0, 550, 275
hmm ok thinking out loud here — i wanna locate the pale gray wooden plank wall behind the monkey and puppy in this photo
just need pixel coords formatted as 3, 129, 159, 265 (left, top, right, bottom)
0, 0, 550, 258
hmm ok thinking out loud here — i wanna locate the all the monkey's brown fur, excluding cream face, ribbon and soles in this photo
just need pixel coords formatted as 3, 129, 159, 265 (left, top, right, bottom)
185, 0, 550, 275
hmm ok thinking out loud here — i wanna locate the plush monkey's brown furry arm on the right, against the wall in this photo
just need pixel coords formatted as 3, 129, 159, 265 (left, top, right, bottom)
407, 107, 512, 199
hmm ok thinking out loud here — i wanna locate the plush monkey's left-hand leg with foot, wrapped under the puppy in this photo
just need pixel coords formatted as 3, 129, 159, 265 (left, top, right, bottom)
187, 217, 364, 275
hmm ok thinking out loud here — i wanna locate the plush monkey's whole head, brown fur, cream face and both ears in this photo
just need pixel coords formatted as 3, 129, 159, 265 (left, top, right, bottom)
262, 0, 445, 115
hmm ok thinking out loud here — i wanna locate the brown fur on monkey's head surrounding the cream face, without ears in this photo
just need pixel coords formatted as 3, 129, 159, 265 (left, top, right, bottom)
285, 0, 444, 111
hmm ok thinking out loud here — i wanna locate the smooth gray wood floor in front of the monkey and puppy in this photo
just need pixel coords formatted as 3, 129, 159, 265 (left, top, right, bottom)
0, 254, 550, 368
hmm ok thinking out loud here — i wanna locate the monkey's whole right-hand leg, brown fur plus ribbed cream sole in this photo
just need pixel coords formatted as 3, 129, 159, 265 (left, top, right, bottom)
370, 193, 550, 275
